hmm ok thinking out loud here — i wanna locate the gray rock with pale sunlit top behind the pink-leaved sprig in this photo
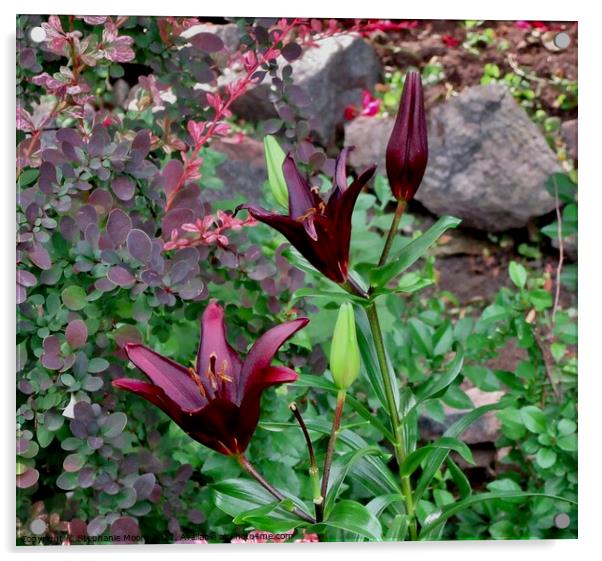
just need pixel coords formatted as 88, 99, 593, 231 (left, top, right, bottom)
230, 35, 380, 145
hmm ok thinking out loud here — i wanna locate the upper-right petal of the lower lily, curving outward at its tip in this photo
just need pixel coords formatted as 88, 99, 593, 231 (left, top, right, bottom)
239, 318, 309, 402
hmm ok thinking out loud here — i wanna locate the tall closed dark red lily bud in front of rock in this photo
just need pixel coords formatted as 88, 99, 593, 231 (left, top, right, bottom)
386, 72, 428, 201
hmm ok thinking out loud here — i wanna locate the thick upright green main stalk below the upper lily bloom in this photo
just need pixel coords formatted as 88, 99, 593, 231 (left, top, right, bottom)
366, 302, 417, 540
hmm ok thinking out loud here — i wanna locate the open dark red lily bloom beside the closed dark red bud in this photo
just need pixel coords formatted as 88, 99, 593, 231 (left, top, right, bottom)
239, 147, 376, 283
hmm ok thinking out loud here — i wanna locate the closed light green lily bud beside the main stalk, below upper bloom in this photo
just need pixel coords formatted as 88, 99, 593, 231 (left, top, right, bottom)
330, 302, 360, 390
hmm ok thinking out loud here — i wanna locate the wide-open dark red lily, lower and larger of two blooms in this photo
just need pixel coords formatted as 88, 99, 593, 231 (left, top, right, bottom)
113, 302, 309, 456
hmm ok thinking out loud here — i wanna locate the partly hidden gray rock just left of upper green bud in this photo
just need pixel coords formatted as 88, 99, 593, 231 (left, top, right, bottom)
203, 137, 267, 203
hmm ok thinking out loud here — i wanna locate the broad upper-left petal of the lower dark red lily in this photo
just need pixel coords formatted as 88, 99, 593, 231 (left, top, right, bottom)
125, 343, 207, 411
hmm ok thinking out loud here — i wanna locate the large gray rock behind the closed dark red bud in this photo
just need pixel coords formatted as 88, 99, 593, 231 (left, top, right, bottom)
345, 85, 561, 232
